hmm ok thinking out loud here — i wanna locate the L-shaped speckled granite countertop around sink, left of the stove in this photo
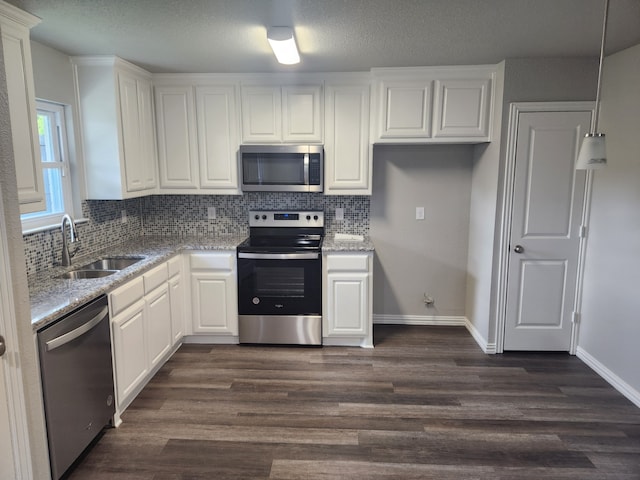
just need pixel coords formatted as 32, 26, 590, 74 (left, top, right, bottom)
29, 236, 246, 331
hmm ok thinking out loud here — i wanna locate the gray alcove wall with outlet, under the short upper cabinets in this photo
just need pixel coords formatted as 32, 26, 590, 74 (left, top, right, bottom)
370, 145, 473, 317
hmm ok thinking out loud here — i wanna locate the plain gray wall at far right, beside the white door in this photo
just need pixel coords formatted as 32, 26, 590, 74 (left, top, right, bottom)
578, 45, 640, 406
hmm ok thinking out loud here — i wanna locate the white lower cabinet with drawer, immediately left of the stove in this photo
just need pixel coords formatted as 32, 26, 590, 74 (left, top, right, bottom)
189, 251, 238, 343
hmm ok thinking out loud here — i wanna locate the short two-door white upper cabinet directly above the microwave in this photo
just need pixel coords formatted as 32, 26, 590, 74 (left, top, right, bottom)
242, 85, 322, 143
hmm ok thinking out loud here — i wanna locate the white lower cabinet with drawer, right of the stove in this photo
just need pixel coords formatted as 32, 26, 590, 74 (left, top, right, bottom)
322, 252, 373, 347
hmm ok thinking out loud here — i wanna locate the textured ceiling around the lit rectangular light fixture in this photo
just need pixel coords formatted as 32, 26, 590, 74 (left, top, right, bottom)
9, 0, 640, 73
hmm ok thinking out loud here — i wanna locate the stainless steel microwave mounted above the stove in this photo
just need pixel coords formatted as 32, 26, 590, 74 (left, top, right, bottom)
240, 145, 324, 192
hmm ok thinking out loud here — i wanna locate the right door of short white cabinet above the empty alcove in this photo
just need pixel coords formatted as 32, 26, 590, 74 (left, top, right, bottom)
433, 78, 491, 141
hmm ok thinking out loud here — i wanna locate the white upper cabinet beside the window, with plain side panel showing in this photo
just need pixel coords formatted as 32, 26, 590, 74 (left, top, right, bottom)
72, 56, 157, 200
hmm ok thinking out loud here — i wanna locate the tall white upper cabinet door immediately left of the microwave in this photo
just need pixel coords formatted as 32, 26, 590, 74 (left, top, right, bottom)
196, 85, 240, 194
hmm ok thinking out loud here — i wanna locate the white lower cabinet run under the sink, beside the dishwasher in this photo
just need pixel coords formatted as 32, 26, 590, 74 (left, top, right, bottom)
109, 256, 184, 424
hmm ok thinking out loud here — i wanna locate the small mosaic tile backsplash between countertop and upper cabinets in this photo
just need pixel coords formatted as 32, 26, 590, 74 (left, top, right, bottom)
23, 192, 370, 275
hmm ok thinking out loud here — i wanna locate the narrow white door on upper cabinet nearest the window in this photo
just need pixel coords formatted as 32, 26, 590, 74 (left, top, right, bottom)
118, 72, 145, 192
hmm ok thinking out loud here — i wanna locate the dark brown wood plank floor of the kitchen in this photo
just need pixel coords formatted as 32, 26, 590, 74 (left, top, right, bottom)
69, 325, 640, 480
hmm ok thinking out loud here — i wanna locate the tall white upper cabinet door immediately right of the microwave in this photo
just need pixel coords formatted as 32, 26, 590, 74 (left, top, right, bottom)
324, 85, 371, 195
